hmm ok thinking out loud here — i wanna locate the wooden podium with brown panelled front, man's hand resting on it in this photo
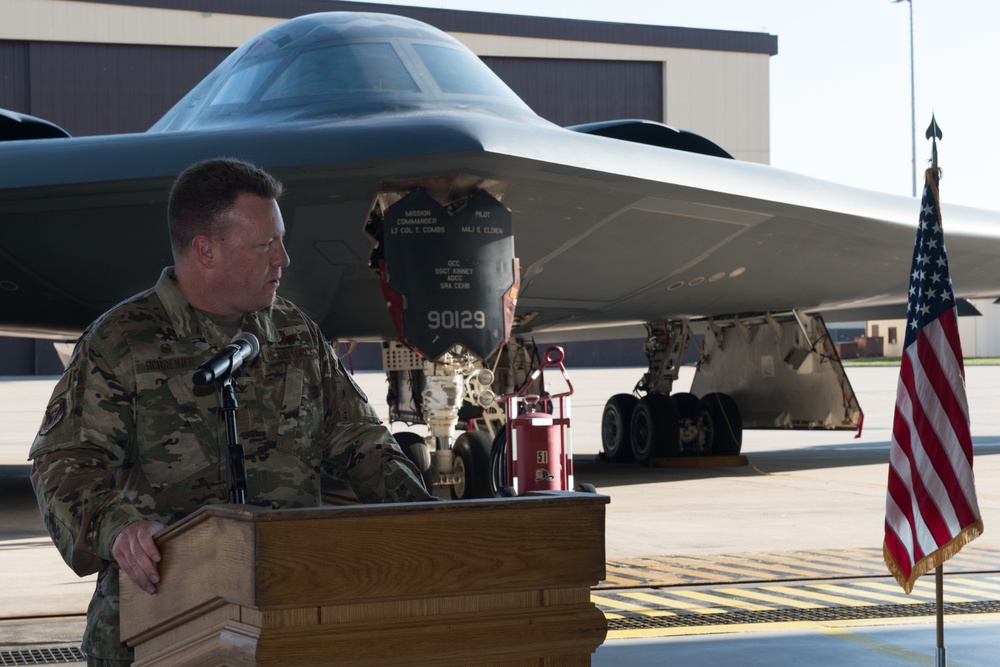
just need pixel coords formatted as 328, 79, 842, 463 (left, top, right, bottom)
121, 492, 608, 667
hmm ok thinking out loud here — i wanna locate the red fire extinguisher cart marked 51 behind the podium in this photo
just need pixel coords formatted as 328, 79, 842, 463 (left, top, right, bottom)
490, 346, 597, 497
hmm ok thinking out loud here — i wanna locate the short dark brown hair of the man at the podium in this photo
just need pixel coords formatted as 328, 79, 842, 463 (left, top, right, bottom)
167, 158, 283, 256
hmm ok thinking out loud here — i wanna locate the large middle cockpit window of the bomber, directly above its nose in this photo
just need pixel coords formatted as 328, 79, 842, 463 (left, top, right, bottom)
261, 42, 419, 101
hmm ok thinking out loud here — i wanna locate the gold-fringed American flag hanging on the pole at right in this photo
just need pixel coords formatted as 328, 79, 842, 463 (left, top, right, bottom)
882, 168, 983, 593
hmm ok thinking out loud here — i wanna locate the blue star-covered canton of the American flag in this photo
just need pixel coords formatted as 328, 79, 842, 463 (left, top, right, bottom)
903, 174, 955, 349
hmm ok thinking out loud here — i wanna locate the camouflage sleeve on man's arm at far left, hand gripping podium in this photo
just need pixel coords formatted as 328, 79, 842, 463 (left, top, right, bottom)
29, 340, 143, 576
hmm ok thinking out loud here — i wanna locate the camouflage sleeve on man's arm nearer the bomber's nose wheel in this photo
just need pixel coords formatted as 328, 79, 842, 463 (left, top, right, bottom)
321, 340, 437, 503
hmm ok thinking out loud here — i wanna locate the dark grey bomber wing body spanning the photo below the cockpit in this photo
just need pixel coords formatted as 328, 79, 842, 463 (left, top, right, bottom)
0, 113, 1000, 339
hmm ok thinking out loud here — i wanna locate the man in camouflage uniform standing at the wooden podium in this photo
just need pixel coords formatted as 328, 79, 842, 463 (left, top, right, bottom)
30, 160, 433, 665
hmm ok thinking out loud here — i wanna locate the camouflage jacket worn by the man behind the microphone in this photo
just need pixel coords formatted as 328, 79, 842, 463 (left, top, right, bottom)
30, 268, 432, 660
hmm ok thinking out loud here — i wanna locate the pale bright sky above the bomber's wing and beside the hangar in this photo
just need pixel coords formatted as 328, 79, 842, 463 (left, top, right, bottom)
369, 0, 1000, 215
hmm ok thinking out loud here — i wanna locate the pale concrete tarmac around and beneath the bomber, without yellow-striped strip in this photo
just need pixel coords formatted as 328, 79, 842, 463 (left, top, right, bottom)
0, 366, 1000, 667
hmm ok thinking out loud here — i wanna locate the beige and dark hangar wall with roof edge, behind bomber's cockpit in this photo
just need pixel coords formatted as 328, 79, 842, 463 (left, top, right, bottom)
0, 0, 777, 163
